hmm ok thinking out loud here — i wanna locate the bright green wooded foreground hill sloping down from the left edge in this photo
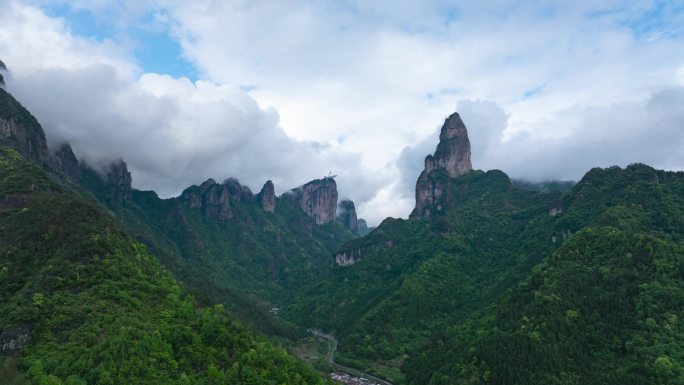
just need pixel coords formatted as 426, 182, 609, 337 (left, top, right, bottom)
0, 146, 332, 384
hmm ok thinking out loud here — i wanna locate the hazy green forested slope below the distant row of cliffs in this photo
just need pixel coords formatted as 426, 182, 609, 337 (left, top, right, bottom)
82, 168, 354, 337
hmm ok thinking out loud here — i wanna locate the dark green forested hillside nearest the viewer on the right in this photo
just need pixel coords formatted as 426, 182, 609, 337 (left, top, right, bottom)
405, 165, 684, 384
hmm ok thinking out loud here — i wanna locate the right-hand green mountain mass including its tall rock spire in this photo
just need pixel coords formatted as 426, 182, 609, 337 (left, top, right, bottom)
286, 115, 684, 384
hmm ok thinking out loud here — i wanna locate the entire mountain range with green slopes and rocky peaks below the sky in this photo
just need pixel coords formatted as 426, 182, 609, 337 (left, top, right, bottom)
0, 62, 684, 385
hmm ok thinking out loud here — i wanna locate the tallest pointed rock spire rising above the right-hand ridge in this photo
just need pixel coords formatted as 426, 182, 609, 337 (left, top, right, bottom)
411, 113, 473, 219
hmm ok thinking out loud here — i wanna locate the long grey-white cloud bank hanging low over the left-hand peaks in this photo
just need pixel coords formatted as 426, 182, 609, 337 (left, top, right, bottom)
0, 0, 386, 219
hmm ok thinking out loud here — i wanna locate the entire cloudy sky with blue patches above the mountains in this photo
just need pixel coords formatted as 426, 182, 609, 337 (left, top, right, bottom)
0, 0, 684, 225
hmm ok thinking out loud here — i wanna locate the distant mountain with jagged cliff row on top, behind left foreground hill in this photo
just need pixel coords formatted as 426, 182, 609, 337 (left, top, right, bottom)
81, 158, 356, 335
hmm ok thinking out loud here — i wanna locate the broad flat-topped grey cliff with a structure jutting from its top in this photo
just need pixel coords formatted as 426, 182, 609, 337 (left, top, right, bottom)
290, 177, 337, 225
